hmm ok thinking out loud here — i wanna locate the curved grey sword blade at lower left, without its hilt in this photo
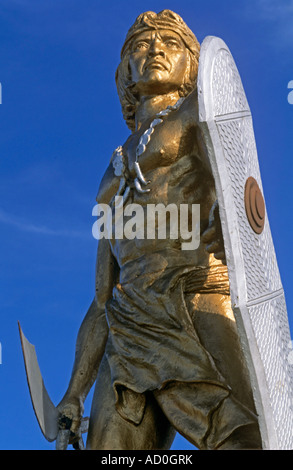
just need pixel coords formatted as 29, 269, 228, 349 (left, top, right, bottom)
18, 323, 59, 442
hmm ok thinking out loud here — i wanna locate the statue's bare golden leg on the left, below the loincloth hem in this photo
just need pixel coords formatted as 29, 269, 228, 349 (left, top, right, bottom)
86, 357, 176, 450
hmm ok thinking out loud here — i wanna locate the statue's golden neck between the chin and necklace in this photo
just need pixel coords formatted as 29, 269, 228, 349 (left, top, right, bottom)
135, 91, 180, 130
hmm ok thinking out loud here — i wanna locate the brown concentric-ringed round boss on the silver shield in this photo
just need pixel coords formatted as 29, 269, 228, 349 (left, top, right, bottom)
244, 176, 265, 234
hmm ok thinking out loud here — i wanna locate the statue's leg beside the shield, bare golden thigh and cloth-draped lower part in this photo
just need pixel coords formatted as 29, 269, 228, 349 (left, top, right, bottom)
154, 294, 262, 449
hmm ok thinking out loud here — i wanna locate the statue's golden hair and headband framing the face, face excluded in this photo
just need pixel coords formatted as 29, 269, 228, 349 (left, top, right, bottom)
116, 10, 200, 131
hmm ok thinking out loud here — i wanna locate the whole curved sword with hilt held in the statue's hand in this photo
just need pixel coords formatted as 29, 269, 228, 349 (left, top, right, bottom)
18, 322, 89, 450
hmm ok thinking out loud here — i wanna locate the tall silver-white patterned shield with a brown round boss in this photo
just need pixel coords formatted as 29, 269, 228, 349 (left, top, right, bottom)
198, 36, 293, 450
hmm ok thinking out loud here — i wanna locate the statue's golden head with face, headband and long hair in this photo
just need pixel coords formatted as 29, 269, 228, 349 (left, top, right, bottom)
116, 10, 200, 130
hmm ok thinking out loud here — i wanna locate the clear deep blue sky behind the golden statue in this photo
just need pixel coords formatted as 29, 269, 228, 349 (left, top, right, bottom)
0, 0, 293, 449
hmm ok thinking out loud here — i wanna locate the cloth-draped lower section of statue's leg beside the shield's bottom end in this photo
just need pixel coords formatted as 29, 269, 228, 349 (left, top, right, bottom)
154, 382, 262, 450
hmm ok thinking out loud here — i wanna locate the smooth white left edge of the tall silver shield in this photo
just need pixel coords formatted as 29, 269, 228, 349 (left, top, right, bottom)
197, 36, 280, 449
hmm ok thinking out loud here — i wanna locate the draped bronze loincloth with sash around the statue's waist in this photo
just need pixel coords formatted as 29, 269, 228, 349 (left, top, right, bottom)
106, 256, 230, 424
